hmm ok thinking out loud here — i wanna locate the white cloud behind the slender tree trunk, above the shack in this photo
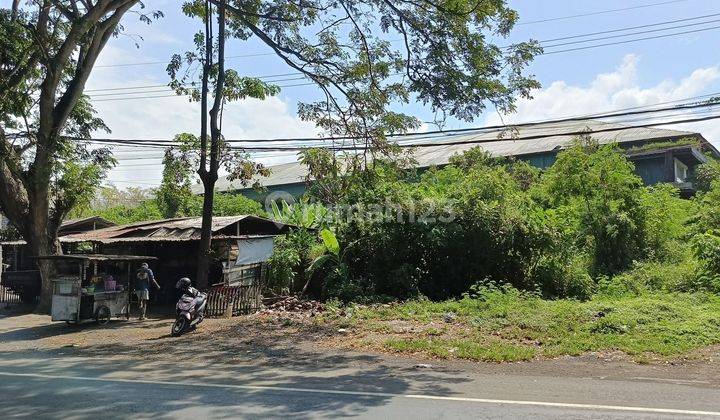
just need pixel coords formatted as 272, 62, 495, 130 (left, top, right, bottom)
86, 45, 318, 187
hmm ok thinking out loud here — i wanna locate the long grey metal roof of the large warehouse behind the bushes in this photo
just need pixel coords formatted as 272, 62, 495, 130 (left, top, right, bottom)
202, 119, 699, 194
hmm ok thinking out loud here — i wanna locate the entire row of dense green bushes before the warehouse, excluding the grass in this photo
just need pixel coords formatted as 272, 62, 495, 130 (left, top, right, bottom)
278, 138, 720, 300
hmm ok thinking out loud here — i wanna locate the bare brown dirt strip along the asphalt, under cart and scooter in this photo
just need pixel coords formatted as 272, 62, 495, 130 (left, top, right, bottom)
0, 311, 720, 387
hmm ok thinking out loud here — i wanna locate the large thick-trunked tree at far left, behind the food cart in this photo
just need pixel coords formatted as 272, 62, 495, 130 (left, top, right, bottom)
0, 0, 160, 310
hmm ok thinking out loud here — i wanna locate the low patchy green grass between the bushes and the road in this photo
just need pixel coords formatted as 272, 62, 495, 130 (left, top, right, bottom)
322, 290, 720, 361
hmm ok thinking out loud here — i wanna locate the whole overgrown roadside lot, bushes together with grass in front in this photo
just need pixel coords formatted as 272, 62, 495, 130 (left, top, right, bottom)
260, 138, 720, 361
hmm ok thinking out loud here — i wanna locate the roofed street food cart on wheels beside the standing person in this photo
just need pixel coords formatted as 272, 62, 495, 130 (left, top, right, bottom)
38, 254, 157, 324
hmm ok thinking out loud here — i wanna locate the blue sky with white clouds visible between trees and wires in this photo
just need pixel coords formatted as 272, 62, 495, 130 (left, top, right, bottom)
57, 0, 720, 188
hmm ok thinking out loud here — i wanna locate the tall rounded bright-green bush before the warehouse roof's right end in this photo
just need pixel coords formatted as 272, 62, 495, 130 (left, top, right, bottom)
537, 139, 647, 275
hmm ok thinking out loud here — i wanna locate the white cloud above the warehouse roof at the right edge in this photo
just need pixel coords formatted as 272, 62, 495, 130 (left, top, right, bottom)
486, 54, 720, 144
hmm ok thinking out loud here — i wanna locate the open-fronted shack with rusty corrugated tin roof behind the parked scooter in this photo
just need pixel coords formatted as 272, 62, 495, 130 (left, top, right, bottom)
62, 215, 290, 303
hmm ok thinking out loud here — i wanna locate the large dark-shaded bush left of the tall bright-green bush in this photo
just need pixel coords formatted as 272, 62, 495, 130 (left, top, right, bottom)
338, 150, 563, 299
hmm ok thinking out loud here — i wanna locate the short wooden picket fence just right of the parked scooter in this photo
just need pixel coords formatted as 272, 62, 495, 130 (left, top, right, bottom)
205, 284, 262, 316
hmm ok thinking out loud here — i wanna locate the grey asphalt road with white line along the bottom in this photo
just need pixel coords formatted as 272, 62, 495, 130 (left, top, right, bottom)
0, 352, 720, 419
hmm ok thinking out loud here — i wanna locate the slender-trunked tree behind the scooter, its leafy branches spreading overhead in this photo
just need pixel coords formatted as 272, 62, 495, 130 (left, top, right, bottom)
168, 0, 540, 285
